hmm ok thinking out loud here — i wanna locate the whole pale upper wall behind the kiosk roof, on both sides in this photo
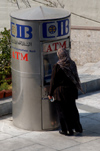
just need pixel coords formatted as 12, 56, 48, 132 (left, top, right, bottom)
0, 0, 100, 30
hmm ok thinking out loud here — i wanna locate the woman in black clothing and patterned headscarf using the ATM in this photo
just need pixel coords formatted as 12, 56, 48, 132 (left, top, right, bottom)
48, 48, 83, 135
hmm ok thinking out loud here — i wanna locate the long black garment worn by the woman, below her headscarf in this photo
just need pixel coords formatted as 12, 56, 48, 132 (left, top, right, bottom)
49, 64, 82, 132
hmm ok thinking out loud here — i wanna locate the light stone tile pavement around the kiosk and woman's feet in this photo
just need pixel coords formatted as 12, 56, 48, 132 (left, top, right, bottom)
0, 91, 100, 151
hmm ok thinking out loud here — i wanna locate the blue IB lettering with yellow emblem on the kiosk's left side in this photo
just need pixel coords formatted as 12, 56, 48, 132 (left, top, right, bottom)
11, 22, 32, 39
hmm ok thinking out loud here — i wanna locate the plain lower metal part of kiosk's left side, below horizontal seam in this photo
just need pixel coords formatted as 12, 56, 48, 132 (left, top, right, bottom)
12, 70, 41, 130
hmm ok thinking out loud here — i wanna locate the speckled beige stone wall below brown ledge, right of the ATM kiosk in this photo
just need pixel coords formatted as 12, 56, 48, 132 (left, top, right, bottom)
71, 28, 100, 65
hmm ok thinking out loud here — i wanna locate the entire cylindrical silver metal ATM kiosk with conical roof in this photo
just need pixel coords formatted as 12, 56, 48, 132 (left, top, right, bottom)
11, 6, 70, 130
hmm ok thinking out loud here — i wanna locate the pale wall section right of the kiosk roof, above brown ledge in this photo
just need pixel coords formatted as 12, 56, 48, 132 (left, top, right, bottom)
64, 0, 100, 27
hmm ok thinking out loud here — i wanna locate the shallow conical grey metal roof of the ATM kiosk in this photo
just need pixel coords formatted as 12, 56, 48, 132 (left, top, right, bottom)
11, 6, 70, 20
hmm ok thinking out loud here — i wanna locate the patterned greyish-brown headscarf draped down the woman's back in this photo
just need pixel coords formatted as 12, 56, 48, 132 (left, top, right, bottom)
57, 48, 84, 93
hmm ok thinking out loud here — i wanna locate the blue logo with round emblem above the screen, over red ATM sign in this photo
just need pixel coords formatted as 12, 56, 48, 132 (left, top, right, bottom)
42, 18, 69, 38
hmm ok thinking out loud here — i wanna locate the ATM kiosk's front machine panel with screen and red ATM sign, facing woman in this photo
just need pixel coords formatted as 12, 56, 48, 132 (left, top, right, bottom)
41, 37, 70, 129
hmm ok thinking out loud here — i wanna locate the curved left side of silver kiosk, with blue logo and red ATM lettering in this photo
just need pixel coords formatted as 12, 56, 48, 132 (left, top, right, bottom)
11, 18, 42, 130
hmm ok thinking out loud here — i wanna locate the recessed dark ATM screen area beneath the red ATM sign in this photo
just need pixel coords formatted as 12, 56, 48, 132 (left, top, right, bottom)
43, 53, 58, 85
